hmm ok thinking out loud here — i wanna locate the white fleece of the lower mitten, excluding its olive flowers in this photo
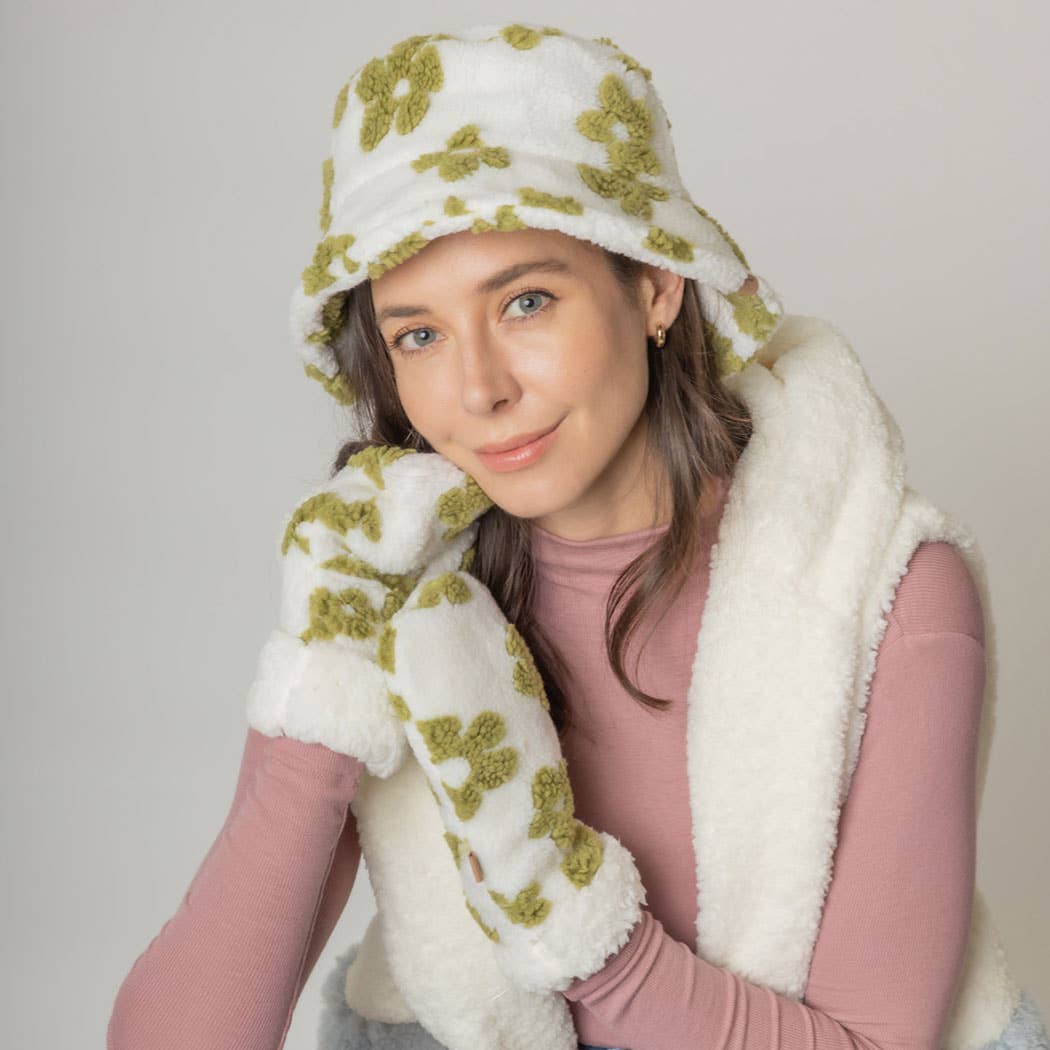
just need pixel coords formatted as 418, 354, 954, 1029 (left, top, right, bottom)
390, 572, 646, 990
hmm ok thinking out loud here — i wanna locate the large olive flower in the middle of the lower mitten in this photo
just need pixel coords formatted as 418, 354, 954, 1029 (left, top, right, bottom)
416, 711, 519, 821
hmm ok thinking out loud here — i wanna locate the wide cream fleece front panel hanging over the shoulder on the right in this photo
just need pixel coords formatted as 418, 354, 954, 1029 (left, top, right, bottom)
687, 315, 903, 999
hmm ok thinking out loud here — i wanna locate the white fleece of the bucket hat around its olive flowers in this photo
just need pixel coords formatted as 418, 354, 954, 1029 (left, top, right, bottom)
289, 23, 783, 390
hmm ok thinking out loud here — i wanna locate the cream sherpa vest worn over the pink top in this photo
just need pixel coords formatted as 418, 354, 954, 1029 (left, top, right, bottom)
320, 315, 1048, 1050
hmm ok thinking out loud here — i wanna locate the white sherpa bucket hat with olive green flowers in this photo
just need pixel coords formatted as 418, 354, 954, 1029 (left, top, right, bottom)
290, 23, 783, 404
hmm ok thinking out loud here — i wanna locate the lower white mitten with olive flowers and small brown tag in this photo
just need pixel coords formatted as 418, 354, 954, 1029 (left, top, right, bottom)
379, 529, 646, 991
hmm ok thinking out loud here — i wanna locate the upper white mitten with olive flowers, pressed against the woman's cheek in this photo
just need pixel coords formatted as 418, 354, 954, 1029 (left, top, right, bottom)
247, 445, 491, 777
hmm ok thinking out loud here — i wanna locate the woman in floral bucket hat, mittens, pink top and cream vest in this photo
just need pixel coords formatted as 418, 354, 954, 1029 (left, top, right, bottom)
109, 18, 1046, 1050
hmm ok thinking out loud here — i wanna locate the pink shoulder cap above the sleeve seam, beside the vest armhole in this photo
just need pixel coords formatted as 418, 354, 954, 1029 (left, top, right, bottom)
883, 541, 985, 647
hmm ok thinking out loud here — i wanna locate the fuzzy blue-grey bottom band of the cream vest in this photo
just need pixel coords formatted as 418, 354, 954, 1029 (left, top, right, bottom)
317, 944, 1050, 1050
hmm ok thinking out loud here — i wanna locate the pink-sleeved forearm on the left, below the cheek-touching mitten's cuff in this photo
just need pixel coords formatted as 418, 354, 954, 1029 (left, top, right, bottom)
106, 728, 363, 1050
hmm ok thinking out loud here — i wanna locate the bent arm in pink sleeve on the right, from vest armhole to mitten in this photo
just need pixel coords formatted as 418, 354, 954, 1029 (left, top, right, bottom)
565, 544, 985, 1050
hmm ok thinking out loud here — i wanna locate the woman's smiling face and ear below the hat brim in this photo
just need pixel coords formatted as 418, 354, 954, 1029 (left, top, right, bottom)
372, 229, 685, 540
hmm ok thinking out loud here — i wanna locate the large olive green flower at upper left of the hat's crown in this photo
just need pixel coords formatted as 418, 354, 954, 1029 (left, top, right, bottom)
356, 34, 444, 151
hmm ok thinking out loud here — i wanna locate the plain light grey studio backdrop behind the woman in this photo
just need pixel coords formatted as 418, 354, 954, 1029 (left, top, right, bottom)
0, 0, 1050, 1050
